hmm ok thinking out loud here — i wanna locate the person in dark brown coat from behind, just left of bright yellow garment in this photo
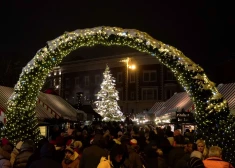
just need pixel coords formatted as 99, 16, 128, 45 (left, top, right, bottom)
79, 134, 108, 168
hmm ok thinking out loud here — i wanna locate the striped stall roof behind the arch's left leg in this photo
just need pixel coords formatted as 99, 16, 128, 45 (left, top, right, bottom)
0, 86, 84, 120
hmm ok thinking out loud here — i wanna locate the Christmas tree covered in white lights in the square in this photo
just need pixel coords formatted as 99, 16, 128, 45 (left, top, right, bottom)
94, 65, 124, 121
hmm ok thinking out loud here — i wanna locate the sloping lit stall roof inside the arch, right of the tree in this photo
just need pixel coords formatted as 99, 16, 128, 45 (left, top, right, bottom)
156, 92, 193, 117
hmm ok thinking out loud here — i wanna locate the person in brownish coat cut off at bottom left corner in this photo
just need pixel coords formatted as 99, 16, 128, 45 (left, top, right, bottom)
0, 145, 12, 168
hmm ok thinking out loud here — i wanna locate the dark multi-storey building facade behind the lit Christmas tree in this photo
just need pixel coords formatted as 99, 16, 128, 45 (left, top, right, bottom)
46, 52, 182, 114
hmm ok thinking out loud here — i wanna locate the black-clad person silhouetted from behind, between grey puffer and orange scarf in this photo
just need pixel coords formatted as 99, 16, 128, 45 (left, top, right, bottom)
29, 142, 62, 168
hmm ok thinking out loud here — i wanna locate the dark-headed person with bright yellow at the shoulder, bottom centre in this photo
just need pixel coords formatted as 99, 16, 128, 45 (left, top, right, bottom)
97, 144, 124, 168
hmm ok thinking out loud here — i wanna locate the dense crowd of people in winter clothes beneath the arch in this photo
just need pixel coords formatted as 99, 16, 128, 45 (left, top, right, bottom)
0, 122, 233, 168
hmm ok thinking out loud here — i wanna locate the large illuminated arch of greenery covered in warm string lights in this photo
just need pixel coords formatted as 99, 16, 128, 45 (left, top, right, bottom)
2, 27, 234, 163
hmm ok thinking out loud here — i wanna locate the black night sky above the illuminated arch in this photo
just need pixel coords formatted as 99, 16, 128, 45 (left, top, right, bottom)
0, 0, 235, 83
